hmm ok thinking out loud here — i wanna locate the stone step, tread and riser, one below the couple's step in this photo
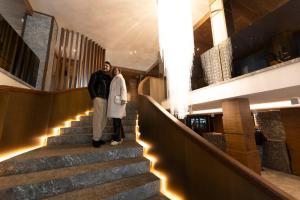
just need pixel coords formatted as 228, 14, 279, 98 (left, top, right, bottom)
0, 158, 149, 199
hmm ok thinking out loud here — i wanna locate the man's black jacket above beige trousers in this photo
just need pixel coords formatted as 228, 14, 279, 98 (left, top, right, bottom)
88, 70, 111, 99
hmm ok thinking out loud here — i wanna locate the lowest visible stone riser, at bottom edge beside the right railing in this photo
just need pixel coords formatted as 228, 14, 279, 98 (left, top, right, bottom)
105, 181, 160, 200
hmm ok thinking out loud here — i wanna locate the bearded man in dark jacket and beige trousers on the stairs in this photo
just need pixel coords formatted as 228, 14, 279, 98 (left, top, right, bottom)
88, 61, 111, 147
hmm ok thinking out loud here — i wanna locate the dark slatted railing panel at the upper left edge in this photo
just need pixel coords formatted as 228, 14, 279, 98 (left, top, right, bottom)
0, 15, 40, 87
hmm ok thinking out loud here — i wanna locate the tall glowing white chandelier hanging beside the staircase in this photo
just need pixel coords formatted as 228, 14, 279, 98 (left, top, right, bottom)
157, 0, 194, 118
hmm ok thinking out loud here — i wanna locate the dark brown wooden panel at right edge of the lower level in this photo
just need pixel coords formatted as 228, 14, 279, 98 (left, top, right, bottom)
280, 108, 300, 176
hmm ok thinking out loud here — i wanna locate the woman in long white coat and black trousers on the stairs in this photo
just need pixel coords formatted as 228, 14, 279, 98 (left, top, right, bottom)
107, 67, 127, 145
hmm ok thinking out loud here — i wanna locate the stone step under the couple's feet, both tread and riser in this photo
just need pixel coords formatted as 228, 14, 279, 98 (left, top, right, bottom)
0, 141, 143, 176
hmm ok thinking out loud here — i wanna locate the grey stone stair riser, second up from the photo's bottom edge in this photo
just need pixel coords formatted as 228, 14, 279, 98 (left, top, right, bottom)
0, 161, 149, 200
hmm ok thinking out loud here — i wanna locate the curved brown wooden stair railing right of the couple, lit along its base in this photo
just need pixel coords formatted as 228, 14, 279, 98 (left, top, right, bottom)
138, 78, 293, 200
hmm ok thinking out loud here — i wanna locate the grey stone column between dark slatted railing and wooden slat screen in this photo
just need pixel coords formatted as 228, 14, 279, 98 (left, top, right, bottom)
23, 12, 58, 90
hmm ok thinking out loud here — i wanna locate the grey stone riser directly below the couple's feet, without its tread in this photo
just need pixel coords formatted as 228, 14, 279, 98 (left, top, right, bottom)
0, 147, 143, 176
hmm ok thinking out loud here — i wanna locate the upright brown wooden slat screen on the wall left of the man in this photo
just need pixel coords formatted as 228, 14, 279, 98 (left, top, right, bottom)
52, 28, 105, 90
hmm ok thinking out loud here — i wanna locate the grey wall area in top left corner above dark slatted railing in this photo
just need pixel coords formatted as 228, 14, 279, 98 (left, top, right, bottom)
0, 0, 26, 36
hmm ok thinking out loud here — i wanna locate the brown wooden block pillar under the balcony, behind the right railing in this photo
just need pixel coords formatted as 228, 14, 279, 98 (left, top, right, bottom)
222, 99, 261, 173
